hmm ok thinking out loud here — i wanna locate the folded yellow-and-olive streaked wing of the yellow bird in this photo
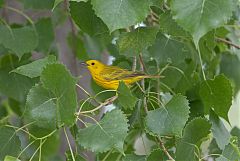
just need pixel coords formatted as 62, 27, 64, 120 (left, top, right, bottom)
100, 66, 145, 81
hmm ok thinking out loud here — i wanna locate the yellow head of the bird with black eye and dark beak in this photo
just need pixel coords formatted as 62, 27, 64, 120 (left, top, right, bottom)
82, 60, 105, 74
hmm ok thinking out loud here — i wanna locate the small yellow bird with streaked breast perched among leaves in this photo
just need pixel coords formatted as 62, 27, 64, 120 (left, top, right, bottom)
81, 60, 159, 90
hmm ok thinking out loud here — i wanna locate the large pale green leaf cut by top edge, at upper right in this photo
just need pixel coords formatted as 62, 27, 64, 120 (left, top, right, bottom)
171, 0, 235, 45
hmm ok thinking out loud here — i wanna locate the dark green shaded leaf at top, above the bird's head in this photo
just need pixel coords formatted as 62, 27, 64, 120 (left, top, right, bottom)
70, 2, 109, 37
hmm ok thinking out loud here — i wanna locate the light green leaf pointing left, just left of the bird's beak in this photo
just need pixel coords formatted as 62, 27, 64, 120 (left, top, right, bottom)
12, 55, 56, 78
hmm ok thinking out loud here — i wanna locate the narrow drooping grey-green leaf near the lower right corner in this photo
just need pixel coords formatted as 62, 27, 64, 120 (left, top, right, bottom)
209, 110, 230, 150
